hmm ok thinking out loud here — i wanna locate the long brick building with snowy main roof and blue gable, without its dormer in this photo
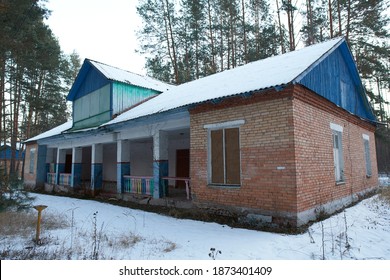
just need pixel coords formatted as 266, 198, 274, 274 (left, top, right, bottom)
27, 38, 378, 226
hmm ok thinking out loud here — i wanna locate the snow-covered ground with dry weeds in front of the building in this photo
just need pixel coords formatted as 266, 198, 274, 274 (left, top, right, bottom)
0, 189, 390, 260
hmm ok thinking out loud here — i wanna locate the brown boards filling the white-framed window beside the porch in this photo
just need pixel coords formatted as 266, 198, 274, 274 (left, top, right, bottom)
210, 128, 241, 185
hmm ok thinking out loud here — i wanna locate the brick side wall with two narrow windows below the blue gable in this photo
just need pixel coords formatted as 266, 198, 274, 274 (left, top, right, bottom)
293, 86, 378, 212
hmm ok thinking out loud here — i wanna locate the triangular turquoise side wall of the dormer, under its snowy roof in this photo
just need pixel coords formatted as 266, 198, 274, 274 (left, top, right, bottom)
112, 82, 158, 115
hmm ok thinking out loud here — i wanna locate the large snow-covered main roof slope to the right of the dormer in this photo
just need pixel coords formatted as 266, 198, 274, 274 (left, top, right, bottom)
102, 38, 344, 126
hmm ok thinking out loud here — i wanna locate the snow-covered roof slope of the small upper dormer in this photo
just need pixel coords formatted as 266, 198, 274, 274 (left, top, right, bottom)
88, 59, 175, 92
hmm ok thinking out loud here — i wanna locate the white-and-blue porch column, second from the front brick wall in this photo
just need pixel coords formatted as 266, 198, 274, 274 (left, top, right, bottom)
116, 140, 130, 193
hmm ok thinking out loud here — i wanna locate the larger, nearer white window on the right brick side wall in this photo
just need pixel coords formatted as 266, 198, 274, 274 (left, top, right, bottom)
330, 123, 344, 183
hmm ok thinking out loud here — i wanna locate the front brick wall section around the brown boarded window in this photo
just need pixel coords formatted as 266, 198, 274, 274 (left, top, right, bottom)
191, 88, 297, 215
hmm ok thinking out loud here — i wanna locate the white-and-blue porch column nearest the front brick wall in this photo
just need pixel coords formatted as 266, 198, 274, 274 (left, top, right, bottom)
153, 131, 168, 198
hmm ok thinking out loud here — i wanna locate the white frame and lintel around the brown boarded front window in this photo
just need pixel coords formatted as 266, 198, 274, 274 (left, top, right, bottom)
203, 120, 245, 187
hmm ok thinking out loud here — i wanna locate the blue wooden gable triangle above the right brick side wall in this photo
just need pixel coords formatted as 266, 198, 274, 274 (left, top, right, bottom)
296, 45, 375, 121
